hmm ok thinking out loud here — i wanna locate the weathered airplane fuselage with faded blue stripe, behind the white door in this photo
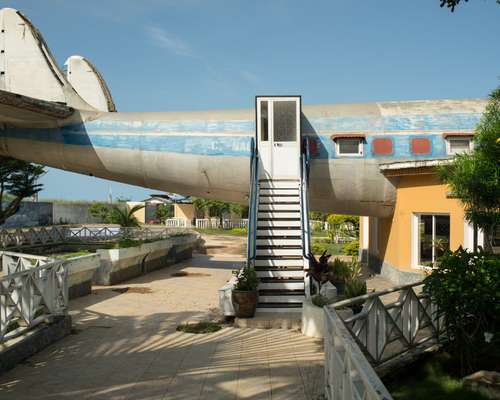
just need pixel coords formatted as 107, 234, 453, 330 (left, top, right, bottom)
0, 100, 485, 217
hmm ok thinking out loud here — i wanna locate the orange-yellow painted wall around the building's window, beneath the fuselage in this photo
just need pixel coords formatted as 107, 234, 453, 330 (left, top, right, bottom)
376, 174, 464, 272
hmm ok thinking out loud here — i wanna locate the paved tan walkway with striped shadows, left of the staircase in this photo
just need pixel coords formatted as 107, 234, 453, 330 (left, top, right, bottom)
0, 237, 323, 400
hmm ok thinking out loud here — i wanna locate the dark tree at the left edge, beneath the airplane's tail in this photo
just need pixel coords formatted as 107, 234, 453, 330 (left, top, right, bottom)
0, 157, 45, 225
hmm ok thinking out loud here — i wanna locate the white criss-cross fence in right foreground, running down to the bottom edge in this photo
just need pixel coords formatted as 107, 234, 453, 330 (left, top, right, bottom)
324, 282, 442, 400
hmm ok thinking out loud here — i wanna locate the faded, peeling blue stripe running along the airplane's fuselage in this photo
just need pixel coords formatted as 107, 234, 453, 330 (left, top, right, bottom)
0, 109, 481, 159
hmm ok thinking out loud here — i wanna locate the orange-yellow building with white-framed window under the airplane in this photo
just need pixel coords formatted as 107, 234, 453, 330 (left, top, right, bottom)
360, 160, 483, 284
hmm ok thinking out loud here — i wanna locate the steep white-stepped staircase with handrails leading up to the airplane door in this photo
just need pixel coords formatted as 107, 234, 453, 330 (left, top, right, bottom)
248, 138, 310, 312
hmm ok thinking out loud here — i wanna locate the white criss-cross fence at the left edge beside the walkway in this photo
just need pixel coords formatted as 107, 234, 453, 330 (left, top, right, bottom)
0, 252, 68, 343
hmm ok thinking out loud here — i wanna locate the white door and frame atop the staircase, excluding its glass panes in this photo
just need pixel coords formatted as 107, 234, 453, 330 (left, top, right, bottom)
255, 96, 302, 179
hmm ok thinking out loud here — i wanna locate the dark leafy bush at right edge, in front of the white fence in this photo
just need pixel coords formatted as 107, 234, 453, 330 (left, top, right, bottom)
424, 247, 500, 374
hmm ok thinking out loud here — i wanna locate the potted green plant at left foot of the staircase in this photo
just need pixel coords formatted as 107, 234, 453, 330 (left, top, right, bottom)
231, 264, 259, 318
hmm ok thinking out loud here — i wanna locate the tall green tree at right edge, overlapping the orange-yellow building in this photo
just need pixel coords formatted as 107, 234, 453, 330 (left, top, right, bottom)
438, 87, 500, 251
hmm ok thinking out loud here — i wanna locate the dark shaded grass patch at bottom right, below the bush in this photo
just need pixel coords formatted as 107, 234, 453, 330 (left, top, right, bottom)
384, 356, 487, 400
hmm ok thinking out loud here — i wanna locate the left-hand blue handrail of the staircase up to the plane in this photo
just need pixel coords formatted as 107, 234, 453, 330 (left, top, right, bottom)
247, 140, 259, 265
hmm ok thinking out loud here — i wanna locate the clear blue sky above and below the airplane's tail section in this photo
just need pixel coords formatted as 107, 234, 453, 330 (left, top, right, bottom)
4, 0, 500, 200
